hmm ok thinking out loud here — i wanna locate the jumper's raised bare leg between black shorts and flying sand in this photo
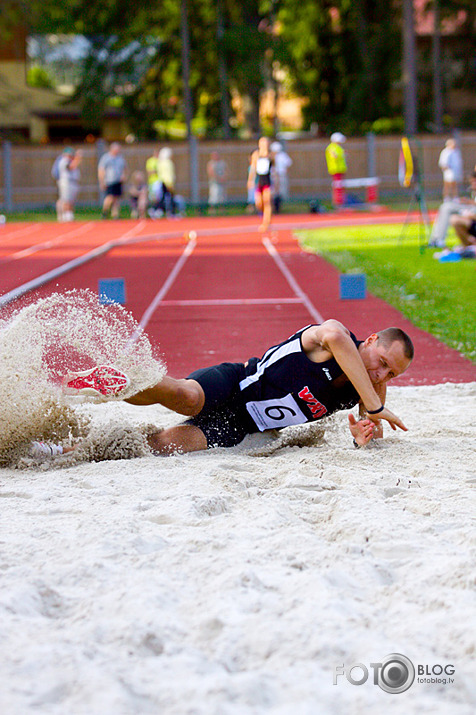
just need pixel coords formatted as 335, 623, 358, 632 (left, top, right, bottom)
126, 376, 205, 417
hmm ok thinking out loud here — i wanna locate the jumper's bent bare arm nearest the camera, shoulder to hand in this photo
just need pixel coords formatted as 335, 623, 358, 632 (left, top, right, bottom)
301, 320, 407, 431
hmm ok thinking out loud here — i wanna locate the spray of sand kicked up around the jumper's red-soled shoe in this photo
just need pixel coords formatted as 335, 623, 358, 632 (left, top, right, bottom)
0, 290, 166, 466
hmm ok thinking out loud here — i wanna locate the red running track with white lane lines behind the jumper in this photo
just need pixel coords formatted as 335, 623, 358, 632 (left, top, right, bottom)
0, 212, 476, 385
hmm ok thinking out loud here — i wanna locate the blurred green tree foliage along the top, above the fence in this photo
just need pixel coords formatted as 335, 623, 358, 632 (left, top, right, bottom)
13, 0, 476, 138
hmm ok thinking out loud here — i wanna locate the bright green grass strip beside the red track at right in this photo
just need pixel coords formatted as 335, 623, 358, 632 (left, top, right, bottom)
299, 224, 476, 362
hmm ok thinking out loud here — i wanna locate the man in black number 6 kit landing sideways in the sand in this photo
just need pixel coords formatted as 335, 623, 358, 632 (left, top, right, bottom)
52, 320, 413, 454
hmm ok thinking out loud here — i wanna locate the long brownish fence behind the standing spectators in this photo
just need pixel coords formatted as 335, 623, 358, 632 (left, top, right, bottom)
0, 132, 476, 212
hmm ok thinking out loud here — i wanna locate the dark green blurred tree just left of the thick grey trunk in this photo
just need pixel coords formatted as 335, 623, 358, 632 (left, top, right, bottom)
278, 0, 401, 132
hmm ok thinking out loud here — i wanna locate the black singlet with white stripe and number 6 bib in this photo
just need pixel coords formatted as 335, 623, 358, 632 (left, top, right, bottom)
239, 326, 361, 431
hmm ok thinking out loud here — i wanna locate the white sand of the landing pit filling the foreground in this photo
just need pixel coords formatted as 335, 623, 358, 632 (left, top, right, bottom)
0, 383, 476, 715
